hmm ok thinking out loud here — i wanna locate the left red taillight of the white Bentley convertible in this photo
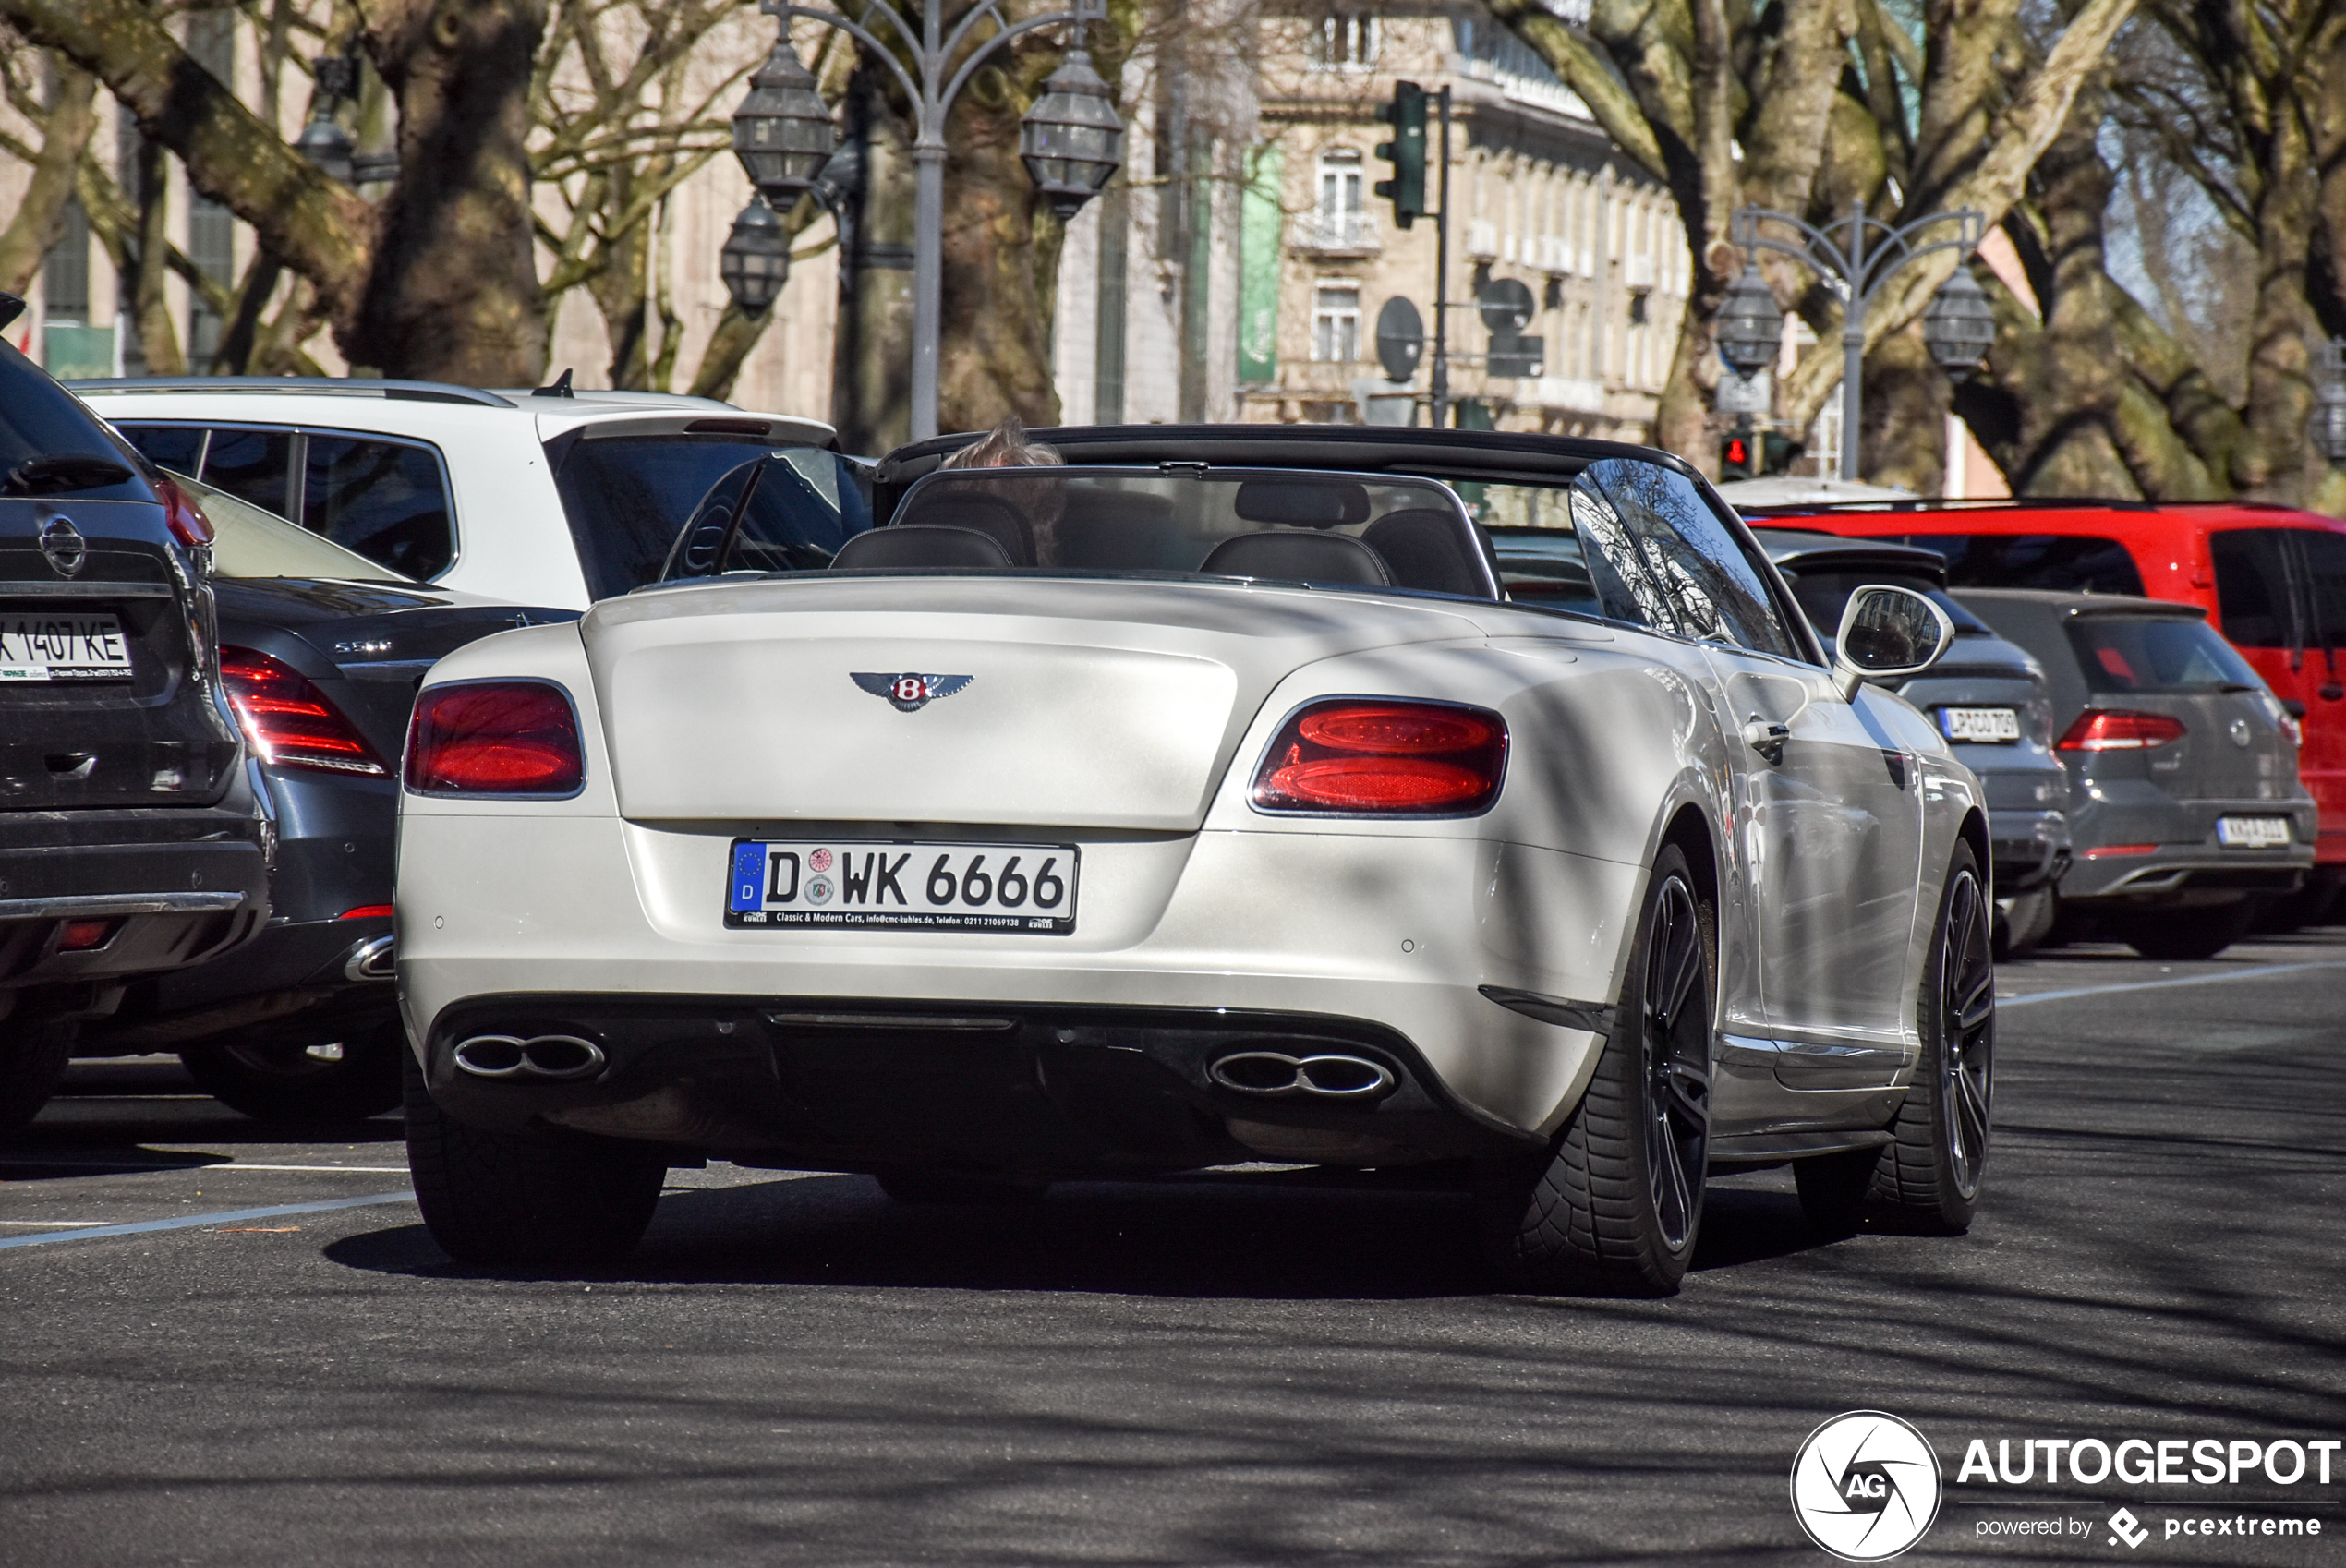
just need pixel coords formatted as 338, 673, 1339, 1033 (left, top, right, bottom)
408, 680, 586, 794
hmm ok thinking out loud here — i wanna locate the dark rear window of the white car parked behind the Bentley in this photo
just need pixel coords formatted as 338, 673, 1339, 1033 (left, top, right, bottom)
553, 431, 870, 600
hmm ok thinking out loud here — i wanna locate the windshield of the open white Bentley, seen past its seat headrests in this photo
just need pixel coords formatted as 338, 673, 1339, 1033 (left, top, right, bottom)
830, 464, 1499, 600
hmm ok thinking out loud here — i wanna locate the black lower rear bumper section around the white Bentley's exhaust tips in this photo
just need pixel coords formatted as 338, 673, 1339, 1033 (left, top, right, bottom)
425, 994, 1539, 1179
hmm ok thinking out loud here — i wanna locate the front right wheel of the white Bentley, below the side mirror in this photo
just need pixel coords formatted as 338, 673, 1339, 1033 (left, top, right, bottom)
1793, 846, 1997, 1236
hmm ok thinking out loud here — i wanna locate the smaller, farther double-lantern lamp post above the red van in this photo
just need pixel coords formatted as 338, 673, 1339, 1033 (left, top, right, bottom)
1720, 199, 1994, 480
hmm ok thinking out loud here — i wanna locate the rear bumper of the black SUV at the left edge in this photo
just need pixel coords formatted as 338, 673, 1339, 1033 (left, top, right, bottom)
0, 806, 270, 1010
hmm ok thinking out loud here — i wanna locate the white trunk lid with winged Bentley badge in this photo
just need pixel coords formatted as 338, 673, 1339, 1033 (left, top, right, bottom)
582, 576, 1481, 832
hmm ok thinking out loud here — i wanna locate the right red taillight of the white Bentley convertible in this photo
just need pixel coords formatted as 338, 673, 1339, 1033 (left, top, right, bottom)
1255, 698, 1506, 815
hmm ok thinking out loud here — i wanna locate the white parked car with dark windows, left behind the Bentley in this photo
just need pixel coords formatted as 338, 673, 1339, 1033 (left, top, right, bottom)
73, 375, 868, 609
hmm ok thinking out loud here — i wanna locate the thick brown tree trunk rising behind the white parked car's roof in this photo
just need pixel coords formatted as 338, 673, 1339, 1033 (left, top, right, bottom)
352, 0, 547, 387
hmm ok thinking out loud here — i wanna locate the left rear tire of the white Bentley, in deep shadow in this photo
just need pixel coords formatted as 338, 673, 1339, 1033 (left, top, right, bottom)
401, 1050, 669, 1268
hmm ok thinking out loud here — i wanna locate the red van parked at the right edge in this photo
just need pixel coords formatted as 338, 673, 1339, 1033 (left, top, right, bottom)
1746, 497, 2346, 919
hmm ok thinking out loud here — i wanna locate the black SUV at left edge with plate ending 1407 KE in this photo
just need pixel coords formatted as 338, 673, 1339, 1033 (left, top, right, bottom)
0, 296, 274, 1129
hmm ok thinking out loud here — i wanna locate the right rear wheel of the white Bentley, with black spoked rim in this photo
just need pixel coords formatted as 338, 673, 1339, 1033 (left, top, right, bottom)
1481, 844, 1717, 1297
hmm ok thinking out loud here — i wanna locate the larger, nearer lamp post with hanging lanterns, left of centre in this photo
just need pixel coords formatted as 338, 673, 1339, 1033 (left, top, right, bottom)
734, 0, 1124, 440
